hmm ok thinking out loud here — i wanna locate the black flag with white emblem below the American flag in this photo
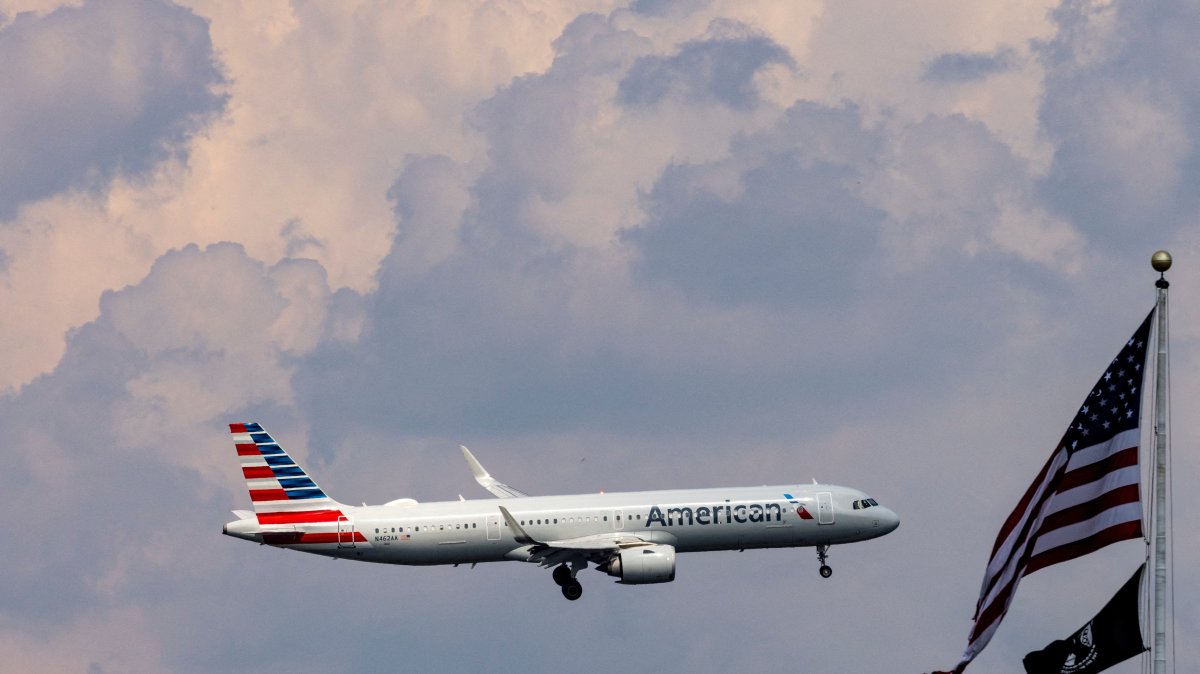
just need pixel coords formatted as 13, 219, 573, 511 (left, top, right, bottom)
1024, 564, 1146, 674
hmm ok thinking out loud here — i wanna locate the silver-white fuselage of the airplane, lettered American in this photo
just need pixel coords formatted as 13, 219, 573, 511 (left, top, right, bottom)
226, 485, 899, 565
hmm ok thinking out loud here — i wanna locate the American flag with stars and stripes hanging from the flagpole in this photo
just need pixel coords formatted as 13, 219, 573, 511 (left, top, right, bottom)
936, 311, 1154, 673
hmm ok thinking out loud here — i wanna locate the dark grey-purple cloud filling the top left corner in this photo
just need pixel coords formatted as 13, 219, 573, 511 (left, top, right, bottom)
0, 1, 226, 221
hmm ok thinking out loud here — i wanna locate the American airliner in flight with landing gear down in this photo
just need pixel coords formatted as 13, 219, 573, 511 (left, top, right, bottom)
223, 422, 900, 601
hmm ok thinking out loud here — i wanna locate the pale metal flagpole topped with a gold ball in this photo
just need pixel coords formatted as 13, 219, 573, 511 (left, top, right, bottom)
1151, 251, 1171, 674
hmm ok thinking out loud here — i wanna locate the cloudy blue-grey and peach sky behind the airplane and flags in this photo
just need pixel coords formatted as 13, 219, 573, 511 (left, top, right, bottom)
0, 0, 1200, 674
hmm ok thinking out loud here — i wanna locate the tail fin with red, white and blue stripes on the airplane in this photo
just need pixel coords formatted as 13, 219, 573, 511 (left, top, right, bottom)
229, 422, 344, 524
